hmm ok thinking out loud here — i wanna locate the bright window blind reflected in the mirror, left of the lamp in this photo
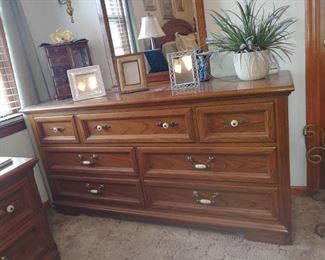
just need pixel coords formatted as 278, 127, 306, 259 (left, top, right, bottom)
105, 0, 131, 56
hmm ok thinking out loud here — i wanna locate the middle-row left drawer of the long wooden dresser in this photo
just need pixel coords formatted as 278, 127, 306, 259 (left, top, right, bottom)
44, 147, 138, 176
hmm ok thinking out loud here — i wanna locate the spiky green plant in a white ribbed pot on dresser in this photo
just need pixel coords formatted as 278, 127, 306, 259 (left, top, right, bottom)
208, 0, 296, 80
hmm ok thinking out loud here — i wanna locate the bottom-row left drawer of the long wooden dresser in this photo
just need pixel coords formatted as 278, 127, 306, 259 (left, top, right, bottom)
51, 175, 143, 206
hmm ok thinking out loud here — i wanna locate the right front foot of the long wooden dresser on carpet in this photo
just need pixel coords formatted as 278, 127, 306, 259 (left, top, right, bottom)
245, 231, 292, 245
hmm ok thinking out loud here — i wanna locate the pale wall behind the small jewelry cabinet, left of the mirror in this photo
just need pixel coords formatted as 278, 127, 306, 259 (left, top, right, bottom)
20, 0, 113, 97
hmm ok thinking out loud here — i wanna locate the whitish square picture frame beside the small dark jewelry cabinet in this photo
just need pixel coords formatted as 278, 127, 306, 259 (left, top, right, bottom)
67, 65, 106, 101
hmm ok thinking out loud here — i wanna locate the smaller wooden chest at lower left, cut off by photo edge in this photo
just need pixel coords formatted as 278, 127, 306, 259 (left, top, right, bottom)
0, 158, 60, 260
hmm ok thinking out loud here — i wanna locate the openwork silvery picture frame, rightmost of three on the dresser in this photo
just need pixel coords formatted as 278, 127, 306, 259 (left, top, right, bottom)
167, 51, 200, 90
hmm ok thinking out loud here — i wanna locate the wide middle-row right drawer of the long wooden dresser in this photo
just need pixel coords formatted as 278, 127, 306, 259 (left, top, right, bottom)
138, 147, 277, 183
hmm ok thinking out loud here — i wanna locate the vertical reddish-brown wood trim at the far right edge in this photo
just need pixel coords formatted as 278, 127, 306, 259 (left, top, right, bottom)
305, 0, 321, 191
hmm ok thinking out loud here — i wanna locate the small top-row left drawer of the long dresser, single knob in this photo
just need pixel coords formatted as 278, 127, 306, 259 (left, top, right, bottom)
33, 115, 79, 144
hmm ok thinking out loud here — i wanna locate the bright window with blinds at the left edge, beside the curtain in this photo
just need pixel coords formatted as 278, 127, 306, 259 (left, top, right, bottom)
0, 19, 20, 118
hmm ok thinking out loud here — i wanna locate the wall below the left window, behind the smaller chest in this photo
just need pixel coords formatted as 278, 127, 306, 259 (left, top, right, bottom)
0, 130, 49, 202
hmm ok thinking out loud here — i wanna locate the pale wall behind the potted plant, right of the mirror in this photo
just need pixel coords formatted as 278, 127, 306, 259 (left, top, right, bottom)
204, 0, 306, 186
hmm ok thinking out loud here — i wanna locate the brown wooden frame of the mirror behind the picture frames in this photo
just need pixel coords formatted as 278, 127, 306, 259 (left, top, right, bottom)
96, 0, 207, 86
